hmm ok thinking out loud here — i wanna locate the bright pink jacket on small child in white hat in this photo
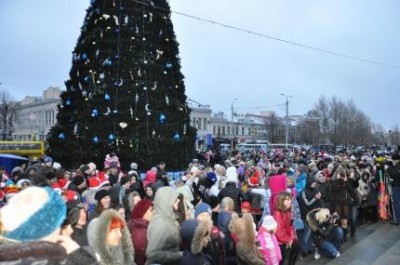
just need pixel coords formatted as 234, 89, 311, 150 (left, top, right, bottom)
257, 227, 282, 265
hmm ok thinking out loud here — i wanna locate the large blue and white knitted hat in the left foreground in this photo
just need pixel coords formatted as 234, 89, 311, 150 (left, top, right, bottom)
0, 187, 66, 241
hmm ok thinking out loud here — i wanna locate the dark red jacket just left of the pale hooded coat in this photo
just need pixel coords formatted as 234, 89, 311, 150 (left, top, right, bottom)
129, 218, 149, 265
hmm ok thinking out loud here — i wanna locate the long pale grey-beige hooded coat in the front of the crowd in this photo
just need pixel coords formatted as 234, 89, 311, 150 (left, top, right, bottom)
146, 187, 182, 265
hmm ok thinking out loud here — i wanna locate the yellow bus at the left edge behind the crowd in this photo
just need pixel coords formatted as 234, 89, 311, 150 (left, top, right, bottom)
0, 141, 44, 157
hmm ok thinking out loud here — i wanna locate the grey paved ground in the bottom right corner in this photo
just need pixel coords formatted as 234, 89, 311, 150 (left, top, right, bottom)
296, 222, 400, 265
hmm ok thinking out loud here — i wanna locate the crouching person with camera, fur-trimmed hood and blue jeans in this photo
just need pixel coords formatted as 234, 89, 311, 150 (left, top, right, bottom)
306, 208, 343, 259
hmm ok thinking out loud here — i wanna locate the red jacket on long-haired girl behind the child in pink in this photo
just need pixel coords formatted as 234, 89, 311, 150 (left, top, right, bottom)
273, 210, 296, 245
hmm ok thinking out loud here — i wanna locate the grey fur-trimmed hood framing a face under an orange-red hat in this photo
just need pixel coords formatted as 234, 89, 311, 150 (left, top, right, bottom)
87, 209, 134, 265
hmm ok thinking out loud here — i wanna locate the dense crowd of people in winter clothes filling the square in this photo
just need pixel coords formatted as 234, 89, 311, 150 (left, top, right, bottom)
0, 146, 400, 265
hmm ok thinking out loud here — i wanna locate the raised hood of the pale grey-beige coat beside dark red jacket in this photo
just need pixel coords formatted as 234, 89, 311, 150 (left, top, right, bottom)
153, 184, 179, 220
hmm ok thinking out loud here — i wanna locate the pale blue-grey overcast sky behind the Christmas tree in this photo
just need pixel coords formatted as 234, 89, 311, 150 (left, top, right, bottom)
0, 0, 400, 129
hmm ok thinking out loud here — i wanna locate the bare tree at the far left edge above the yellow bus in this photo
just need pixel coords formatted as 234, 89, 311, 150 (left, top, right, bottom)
0, 90, 17, 141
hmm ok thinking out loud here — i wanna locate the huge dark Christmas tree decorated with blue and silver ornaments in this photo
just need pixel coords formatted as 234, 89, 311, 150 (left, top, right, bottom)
47, 0, 196, 169
